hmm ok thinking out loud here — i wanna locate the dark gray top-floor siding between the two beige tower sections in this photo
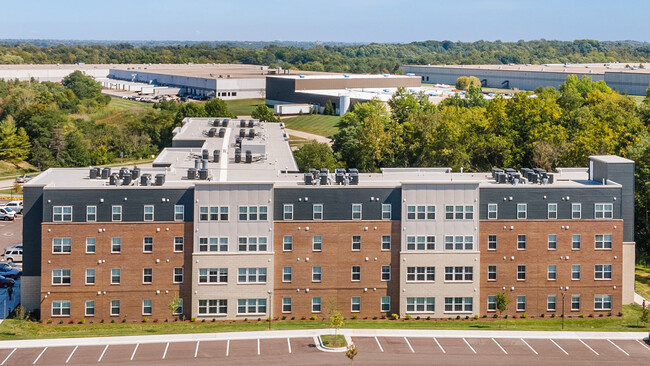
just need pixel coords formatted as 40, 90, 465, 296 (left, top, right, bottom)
273, 186, 402, 220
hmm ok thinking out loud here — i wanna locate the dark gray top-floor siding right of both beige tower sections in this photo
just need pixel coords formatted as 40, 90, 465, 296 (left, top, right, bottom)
479, 184, 625, 220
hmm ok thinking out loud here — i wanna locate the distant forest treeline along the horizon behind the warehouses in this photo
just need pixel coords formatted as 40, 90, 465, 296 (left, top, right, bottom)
0, 40, 650, 73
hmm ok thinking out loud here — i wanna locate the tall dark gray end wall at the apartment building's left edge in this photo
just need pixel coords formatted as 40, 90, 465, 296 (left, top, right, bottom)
23, 187, 43, 276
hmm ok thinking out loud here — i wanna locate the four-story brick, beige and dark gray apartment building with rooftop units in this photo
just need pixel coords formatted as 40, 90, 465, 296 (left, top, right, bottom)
21, 117, 635, 322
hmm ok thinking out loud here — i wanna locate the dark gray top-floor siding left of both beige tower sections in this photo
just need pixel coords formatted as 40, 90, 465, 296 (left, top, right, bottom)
43, 188, 194, 222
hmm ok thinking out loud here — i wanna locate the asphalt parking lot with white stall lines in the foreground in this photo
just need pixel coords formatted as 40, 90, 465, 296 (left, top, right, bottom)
0, 333, 650, 366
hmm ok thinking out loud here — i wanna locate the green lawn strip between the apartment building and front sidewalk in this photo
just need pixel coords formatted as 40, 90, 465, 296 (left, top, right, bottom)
0, 305, 648, 340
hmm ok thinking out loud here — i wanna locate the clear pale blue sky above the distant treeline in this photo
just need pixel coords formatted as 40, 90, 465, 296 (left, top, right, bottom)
0, 0, 650, 43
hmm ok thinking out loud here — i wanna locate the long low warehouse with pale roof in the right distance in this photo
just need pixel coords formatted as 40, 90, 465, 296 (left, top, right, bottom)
401, 63, 650, 95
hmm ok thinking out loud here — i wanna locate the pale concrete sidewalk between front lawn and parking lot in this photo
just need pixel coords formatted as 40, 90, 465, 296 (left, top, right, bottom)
0, 329, 648, 349
